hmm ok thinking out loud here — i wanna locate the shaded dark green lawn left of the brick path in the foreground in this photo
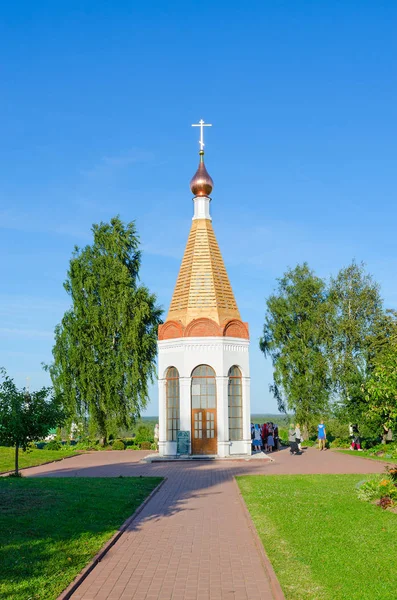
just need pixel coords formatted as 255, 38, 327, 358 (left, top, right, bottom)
0, 477, 161, 600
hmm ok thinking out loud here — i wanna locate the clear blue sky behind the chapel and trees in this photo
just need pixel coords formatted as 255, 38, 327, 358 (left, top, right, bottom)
0, 0, 397, 414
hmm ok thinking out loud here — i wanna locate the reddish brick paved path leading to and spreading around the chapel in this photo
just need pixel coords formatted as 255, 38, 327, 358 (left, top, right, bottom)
25, 449, 384, 600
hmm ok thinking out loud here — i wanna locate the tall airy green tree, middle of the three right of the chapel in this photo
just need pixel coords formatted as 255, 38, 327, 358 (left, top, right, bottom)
329, 261, 383, 421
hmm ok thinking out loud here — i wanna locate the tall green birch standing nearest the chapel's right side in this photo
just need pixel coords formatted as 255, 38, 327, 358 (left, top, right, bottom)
259, 263, 330, 427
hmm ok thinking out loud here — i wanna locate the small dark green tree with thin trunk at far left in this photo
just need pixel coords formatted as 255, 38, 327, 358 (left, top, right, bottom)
0, 369, 65, 475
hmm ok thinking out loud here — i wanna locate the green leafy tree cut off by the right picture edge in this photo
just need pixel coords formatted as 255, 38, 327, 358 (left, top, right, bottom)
364, 311, 397, 439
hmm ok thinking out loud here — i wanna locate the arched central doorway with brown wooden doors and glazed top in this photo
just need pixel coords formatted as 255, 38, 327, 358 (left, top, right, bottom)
191, 365, 218, 454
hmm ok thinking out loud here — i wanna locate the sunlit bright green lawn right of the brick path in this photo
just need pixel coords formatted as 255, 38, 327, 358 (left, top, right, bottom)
237, 475, 397, 600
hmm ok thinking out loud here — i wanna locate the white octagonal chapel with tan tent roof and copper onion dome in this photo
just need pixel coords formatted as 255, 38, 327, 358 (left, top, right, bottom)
158, 120, 251, 457
